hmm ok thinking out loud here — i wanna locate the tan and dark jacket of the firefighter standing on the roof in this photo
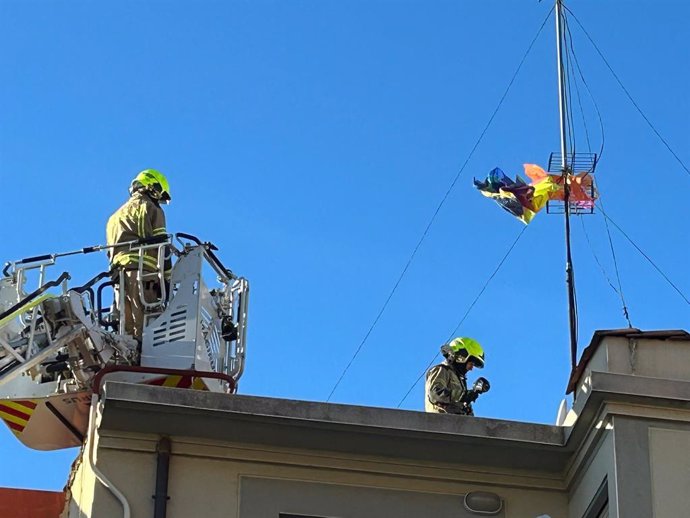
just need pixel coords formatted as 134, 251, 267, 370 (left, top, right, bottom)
424, 363, 472, 415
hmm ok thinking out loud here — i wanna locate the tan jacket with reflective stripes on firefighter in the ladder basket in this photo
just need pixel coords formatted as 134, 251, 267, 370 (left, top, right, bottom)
106, 192, 172, 277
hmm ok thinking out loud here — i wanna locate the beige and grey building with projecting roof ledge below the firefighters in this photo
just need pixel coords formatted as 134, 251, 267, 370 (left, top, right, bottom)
63, 329, 690, 518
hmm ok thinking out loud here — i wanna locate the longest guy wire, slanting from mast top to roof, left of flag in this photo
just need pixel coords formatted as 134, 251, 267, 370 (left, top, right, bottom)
326, 7, 554, 402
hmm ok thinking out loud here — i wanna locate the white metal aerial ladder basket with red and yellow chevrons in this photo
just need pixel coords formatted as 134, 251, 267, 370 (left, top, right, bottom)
0, 233, 249, 450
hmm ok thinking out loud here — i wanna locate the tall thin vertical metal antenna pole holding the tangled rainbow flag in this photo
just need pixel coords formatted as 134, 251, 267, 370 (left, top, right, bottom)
556, 0, 577, 370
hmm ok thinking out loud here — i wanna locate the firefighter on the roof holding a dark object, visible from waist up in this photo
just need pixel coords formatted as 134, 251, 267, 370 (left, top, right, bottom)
424, 338, 490, 415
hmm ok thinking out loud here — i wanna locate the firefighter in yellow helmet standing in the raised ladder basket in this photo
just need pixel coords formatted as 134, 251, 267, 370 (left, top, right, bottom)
106, 169, 172, 343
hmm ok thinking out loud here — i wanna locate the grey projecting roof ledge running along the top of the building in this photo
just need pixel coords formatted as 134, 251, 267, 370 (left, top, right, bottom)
100, 372, 690, 473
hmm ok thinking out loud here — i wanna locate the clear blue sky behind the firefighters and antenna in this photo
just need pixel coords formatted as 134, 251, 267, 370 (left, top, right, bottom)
0, 0, 690, 489
